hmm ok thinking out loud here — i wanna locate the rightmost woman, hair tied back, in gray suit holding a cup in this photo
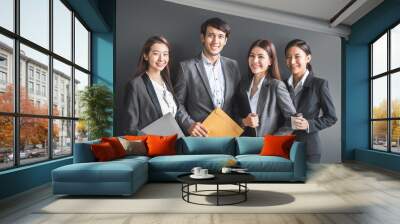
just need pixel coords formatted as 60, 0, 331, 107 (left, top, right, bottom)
285, 39, 337, 162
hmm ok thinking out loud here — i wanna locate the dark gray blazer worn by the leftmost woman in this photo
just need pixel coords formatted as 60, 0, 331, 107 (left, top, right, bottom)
123, 74, 181, 135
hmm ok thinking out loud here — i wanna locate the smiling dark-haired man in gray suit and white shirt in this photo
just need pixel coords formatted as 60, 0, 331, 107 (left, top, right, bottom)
174, 18, 241, 137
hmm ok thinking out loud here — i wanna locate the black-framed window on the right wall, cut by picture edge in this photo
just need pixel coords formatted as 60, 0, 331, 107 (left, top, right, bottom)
370, 24, 400, 153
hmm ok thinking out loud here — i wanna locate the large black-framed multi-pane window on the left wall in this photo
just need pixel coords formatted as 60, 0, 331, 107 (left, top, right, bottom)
0, 0, 91, 170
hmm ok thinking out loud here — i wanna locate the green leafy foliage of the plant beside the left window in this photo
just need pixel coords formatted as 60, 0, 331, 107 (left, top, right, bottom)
79, 84, 113, 139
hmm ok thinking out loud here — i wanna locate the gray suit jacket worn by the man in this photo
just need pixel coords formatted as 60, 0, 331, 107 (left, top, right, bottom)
174, 54, 241, 132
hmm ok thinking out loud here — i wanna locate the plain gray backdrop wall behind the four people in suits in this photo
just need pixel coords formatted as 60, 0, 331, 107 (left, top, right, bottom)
114, 0, 341, 162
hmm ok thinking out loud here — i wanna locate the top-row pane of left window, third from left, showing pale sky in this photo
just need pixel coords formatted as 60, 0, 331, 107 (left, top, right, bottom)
53, 0, 72, 60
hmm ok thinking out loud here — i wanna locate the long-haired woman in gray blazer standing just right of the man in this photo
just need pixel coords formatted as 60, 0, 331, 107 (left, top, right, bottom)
238, 40, 296, 136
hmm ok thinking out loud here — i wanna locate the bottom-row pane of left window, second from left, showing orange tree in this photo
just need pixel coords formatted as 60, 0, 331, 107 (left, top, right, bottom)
19, 117, 49, 164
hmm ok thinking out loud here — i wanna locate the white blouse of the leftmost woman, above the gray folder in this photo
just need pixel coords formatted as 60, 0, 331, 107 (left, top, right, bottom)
150, 79, 177, 117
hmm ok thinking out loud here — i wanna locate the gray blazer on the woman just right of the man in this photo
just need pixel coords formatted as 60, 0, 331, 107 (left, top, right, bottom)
238, 76, 296, 136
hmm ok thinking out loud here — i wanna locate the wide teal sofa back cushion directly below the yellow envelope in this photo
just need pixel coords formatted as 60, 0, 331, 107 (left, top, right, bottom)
178, 137, 235, 155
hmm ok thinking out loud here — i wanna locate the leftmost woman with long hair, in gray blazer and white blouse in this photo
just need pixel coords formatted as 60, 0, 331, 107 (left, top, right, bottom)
124, 36, 179, 134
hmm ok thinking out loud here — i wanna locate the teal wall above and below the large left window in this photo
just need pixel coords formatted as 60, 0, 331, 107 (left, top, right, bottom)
0, 0, 115, 199
